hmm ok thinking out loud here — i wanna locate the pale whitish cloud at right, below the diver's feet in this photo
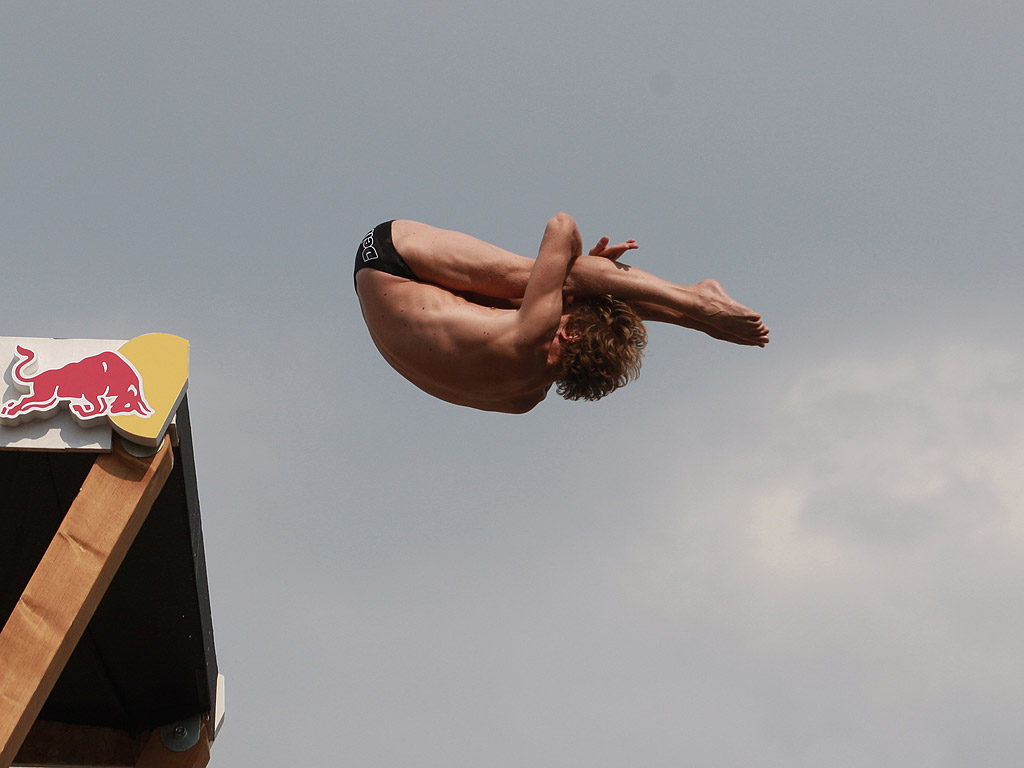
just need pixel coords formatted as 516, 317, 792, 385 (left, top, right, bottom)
635, 348, 1024, 695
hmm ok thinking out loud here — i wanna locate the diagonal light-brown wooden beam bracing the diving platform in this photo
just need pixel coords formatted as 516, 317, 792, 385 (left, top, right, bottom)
0, 438, 173, 768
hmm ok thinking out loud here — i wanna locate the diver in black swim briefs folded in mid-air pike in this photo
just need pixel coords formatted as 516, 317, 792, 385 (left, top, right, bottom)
355, 213, 768, 414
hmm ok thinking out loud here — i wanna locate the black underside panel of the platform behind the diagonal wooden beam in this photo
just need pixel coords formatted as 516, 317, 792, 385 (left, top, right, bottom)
0, 400, 217, 735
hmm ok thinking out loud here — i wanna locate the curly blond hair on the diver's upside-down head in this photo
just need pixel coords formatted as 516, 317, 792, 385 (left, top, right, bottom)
557, 295, 647, 400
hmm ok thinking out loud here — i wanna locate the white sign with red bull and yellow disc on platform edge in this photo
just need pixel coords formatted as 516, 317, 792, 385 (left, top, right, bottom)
0, 334, 188, 450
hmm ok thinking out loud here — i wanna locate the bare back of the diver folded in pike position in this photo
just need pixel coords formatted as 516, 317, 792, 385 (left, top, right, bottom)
356, 269, 550, 413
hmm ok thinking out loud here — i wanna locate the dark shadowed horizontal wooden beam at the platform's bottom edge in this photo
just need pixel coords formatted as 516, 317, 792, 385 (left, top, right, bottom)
14, 720, 144, 768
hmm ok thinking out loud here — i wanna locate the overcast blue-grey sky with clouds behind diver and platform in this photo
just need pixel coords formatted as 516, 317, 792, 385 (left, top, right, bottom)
0, 0, 1024, 768
